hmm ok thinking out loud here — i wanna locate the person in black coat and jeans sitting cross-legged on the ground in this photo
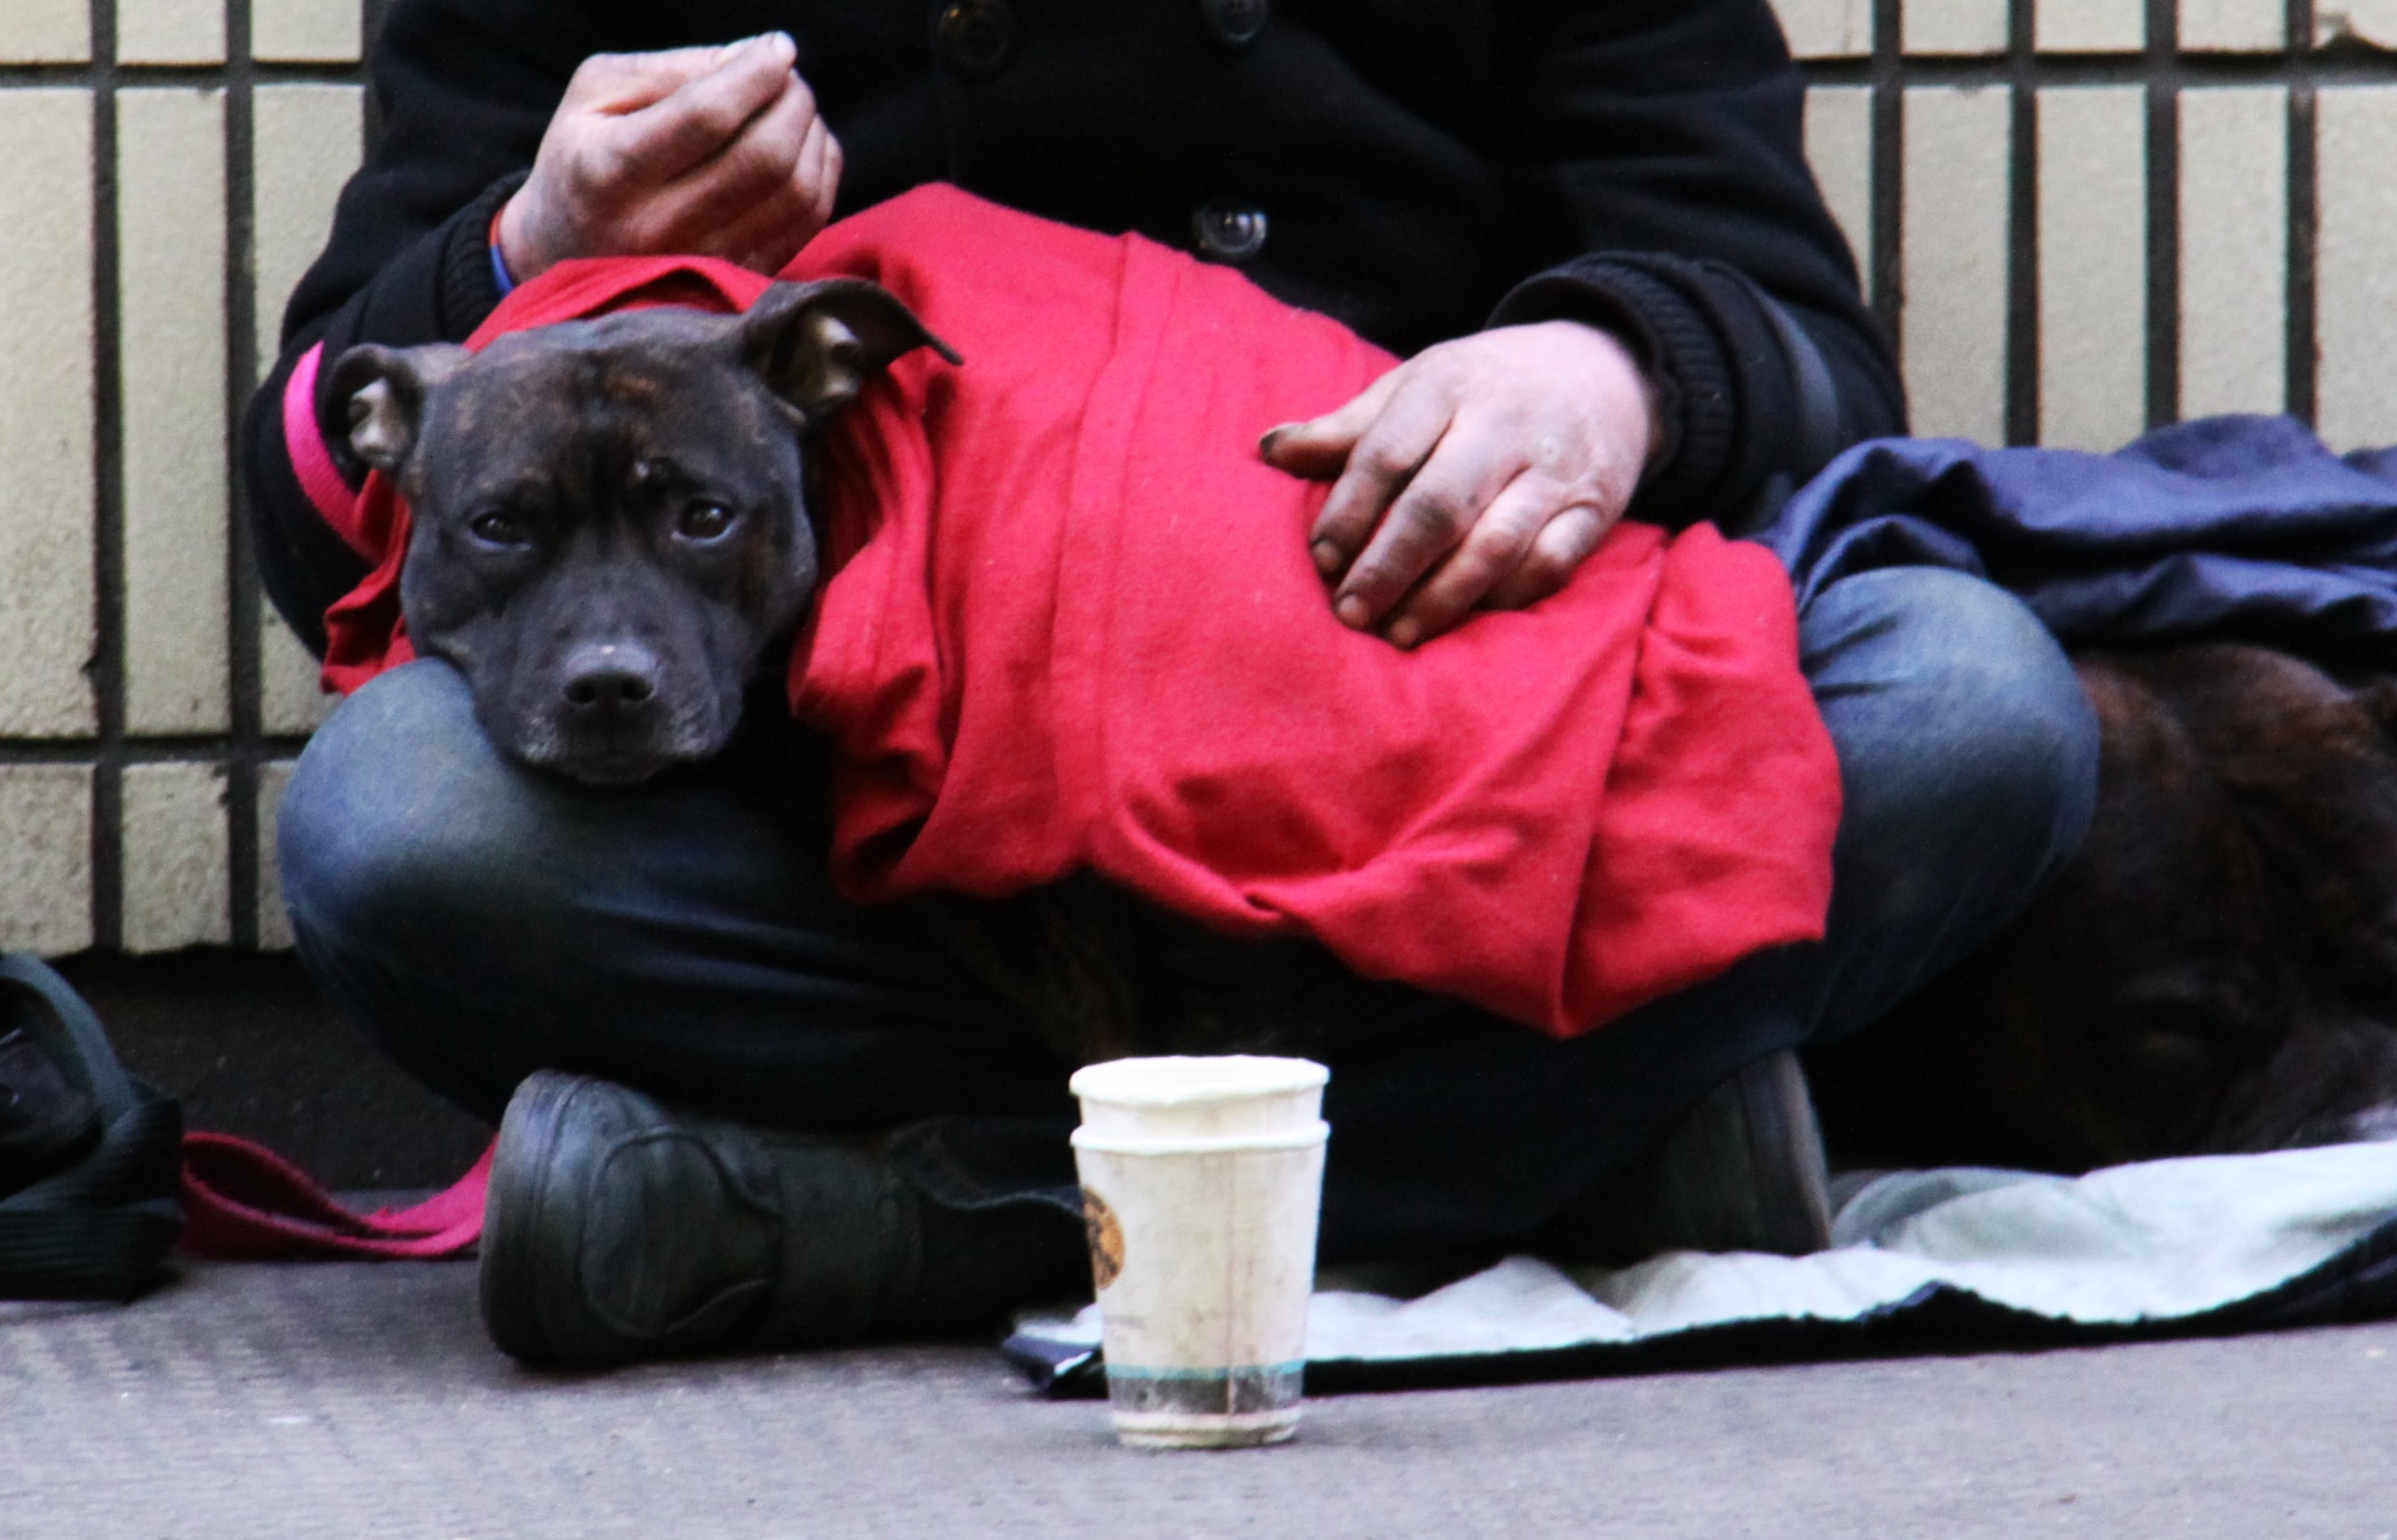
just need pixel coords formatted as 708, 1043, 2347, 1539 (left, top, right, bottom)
244, 0, 2095, 1363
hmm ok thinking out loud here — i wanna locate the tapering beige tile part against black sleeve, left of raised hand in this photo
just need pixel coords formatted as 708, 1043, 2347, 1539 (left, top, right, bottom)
252, 86, 365, 376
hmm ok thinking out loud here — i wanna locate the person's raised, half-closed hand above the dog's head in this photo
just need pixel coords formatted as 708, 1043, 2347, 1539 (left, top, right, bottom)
499, 31, 841, 283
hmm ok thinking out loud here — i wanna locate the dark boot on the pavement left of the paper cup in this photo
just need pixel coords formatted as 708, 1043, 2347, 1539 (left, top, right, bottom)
481, 1070, 1088, 1367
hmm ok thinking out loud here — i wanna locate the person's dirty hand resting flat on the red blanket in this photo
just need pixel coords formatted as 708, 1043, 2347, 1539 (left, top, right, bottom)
1259, 321, 1659, 647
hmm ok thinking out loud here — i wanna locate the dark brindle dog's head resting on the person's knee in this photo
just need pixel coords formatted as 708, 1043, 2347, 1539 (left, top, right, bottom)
333, 278, 957, 786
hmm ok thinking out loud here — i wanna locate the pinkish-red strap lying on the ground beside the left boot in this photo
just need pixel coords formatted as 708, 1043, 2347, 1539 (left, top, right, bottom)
182, 1133, 491, 1262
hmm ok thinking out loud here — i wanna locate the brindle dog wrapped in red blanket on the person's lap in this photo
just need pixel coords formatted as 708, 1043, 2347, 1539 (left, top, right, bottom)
333, 281, 1390, 1061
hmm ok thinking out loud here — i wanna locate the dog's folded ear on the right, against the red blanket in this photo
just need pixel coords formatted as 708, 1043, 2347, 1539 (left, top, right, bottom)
738, 278, 964, 426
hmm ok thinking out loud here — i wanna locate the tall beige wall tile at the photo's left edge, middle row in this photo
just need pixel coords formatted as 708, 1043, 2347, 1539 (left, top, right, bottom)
0, 89, 95, 738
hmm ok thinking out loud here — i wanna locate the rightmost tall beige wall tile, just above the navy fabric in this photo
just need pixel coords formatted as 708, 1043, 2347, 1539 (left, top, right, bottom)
2316, 86, 2397, 447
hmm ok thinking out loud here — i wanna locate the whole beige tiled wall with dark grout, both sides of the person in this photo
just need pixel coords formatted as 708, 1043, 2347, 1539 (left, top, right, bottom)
0, 0, 2397, 954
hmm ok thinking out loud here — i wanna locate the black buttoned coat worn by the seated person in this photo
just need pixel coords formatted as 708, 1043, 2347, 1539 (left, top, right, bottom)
244, 0, 1903, 644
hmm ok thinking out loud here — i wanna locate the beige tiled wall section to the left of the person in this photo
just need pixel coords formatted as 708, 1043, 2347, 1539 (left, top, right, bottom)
0, 0, 367, 954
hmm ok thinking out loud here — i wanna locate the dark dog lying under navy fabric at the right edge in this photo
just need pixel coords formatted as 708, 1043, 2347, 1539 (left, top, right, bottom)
1810, 644, 2397, 1172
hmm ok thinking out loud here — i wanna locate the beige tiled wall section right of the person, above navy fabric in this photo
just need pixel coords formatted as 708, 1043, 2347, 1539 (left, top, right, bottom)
1779, 0, 2397, 447
